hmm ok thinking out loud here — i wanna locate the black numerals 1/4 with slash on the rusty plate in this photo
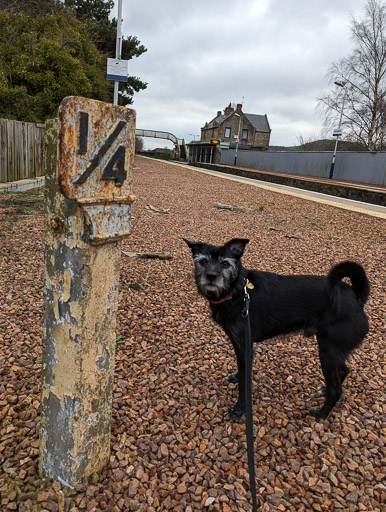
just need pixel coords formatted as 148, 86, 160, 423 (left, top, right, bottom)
75, 112, 127, 186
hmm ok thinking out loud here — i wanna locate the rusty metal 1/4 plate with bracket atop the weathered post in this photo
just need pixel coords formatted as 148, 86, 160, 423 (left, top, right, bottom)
58, 96, 135, 243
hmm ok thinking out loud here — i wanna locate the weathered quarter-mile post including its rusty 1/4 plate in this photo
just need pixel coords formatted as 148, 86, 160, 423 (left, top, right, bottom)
40, 97, 135, 484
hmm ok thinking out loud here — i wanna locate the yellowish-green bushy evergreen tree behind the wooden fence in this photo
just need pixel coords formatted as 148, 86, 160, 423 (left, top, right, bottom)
0, 11, 109, 122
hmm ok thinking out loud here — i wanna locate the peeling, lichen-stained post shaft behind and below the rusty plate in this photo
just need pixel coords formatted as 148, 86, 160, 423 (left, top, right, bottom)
40, 99, 133, 485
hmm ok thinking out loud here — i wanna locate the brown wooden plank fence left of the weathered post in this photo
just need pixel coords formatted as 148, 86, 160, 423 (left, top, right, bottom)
0, 119, 45, 183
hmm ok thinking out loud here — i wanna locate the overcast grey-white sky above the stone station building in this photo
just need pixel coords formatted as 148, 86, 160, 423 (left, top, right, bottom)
120, 0, 365, 147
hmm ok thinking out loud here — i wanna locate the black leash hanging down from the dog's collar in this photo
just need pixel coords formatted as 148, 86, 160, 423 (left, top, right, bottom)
241, 279, 257, 512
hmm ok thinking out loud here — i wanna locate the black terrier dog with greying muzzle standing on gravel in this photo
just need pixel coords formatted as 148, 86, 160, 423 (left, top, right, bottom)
184, 238, 370, 419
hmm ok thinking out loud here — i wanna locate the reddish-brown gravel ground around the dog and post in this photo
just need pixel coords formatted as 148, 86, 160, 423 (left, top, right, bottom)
0, 158, 386, 512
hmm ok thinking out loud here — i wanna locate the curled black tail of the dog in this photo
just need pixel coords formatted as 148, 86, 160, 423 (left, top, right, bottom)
327, 261, 370, 308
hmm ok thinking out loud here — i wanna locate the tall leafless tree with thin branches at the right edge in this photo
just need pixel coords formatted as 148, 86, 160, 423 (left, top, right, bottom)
317, 0, 386, 151
